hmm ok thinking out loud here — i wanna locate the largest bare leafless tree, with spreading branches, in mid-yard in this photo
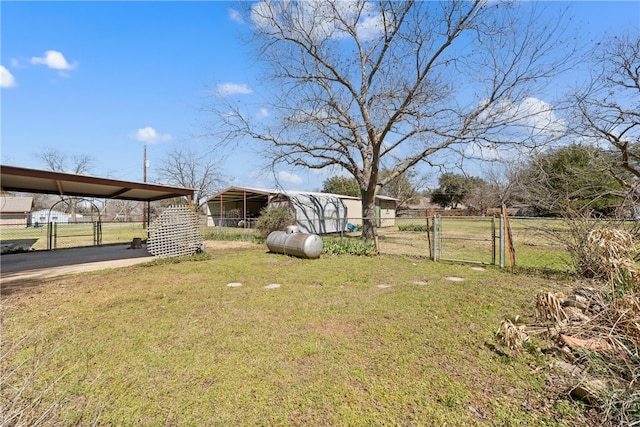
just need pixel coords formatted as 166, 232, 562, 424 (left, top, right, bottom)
212, 0, 571, 239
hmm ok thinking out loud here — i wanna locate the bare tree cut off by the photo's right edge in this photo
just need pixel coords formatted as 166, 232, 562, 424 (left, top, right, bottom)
575, 33, 640, 215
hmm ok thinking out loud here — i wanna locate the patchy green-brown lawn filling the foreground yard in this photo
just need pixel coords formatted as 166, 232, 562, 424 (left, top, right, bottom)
0, 242, 592, 426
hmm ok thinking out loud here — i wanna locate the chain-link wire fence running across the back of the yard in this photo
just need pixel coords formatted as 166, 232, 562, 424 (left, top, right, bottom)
0, 216, 596, 271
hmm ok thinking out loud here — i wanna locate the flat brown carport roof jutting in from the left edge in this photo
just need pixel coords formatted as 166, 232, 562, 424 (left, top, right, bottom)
0, 165, 195, 202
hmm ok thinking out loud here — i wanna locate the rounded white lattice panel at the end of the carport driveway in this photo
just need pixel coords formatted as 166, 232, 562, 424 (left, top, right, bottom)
147, 206, 204, 258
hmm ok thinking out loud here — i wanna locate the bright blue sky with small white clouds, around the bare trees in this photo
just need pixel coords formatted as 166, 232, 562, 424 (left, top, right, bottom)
0, 1, 640, 190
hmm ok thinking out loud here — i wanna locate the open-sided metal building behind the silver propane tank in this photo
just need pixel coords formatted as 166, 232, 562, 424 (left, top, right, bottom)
206, 187, 396, 234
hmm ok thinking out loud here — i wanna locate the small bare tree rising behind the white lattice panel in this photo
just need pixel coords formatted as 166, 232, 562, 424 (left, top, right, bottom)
156, 147, 222, 208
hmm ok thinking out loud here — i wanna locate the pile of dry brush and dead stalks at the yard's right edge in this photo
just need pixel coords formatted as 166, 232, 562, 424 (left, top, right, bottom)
496, 228, 640, 426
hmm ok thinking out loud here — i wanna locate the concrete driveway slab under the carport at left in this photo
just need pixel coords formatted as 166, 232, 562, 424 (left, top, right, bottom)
0, 244, 155, 284
